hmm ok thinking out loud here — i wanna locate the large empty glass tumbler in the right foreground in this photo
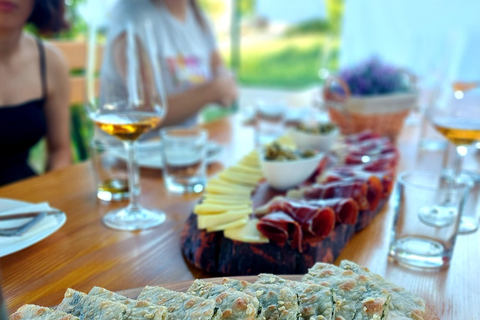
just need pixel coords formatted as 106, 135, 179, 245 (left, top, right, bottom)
389, 171, 469, 268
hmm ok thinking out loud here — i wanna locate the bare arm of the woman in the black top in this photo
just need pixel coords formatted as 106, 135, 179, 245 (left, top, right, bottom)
45, 44, 72, 171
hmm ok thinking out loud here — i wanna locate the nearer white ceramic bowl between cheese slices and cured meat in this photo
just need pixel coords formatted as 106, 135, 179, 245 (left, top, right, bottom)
260, 153, 324, 191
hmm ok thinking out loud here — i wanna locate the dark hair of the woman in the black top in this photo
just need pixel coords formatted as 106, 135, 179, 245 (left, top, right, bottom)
27, 0, 69, 34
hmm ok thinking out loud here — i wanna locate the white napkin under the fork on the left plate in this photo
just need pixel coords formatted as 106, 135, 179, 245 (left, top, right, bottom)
0, 202, 58, 247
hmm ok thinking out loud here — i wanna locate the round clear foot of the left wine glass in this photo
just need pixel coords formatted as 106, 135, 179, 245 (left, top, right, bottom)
103, 206, 167, 231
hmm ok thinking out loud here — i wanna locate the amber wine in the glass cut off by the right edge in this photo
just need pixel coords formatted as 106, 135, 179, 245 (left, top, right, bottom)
433, 117, 480, 145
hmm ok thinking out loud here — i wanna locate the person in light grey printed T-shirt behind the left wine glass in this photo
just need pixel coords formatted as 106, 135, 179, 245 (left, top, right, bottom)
101, 0, 237, 126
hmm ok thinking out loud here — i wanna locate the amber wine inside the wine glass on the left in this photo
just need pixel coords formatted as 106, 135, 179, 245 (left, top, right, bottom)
93, 111, 162, 141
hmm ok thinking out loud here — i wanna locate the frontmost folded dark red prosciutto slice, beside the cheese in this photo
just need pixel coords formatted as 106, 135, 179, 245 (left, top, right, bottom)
257, 212, 303, 251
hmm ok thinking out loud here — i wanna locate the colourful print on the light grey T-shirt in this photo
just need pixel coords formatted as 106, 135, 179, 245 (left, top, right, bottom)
166, 54, 208, 89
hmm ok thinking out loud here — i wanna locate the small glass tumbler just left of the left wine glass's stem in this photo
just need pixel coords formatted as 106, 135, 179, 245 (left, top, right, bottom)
90, 138, 140, 201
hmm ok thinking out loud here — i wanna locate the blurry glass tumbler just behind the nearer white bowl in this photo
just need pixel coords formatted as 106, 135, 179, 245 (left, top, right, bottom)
255, 101, 287, 146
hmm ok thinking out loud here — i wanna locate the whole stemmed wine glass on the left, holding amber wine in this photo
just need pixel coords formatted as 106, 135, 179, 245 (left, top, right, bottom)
86, 19, 166, 230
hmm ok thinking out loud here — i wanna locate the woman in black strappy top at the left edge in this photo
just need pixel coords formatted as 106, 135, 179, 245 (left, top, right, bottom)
0, 0, 71, 185
